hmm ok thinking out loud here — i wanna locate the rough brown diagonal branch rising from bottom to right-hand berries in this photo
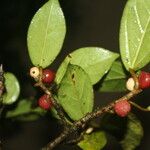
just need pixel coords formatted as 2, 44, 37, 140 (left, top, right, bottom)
43, 89, 142, 150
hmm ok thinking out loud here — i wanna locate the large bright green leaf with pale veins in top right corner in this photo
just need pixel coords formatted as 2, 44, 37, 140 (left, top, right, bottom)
120, 0, 150, 70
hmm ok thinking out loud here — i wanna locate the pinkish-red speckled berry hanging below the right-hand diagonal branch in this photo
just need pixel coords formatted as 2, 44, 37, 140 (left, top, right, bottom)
114, 100, 131, 117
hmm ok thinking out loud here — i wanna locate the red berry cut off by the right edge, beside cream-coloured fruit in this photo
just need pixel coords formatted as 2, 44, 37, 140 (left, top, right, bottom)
138, 71, 150, 89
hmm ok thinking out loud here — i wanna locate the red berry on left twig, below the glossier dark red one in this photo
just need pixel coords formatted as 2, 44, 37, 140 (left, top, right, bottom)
38, 94, 52, 110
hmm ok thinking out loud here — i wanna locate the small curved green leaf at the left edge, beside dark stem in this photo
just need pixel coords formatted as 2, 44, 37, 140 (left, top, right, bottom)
2, 72, 20, 104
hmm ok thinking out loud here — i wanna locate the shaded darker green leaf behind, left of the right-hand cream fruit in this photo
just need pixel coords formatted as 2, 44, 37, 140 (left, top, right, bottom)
98, 61, 127, 92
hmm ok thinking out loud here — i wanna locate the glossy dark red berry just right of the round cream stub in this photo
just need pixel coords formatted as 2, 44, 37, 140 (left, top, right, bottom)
42, 69, 55, 84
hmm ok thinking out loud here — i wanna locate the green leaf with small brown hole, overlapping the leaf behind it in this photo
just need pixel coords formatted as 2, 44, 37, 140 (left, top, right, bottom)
58, 64, 93, 120
